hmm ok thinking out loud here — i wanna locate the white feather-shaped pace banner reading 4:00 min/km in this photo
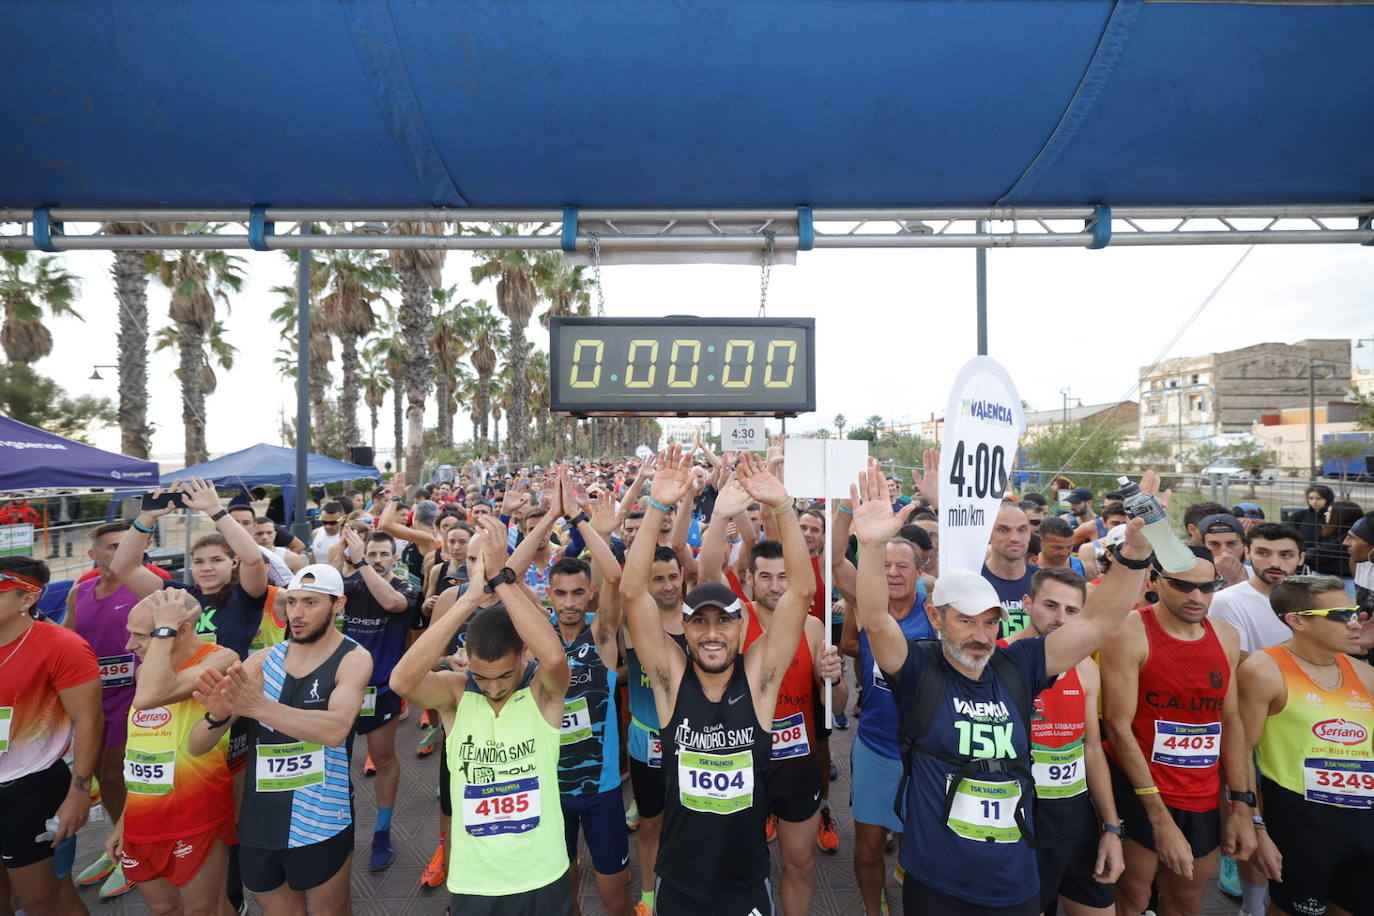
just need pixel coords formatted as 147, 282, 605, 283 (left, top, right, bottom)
940, 356, 1025, 570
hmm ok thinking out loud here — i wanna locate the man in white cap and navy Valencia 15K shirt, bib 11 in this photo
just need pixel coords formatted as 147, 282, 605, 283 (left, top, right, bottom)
852, 463, 1158, 916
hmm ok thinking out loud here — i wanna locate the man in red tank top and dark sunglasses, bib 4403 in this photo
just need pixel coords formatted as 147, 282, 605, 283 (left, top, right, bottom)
1102, 547, 1254, 913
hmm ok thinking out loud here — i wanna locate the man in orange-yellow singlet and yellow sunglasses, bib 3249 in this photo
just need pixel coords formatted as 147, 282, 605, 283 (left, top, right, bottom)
1238, 575, 1374, 916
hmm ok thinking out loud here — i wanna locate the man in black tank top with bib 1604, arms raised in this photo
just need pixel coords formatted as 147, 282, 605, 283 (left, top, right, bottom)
621, 444, 815, 916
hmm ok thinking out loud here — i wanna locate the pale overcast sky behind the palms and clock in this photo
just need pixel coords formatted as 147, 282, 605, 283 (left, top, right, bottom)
37, 244, 1374, 467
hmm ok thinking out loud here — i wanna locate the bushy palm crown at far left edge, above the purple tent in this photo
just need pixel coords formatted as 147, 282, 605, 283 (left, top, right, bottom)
0, 250, 81, 364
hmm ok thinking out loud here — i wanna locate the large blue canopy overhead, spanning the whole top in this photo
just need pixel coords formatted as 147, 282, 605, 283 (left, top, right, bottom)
0, 0, 1374, 209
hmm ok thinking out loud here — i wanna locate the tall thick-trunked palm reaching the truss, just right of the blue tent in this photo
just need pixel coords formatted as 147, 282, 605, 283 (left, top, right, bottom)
387, 222, 445, 479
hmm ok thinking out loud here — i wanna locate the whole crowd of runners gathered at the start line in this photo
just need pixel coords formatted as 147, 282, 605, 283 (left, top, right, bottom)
0, 444, 1374, 916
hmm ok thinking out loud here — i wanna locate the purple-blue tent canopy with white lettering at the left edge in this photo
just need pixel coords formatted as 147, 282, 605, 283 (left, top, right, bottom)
0, 416, 158, 490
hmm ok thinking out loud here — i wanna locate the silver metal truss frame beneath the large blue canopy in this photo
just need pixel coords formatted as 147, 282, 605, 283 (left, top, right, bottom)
0, 203, 1374, 252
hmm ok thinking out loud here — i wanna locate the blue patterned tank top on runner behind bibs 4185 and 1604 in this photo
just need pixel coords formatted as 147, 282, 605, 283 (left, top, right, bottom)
558, 626, 620, 795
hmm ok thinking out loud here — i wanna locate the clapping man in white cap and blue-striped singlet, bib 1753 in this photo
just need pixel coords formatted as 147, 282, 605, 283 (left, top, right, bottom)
188, 563, 372, 916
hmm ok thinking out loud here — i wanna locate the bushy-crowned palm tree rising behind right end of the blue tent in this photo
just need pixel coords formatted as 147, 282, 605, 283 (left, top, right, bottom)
312, 250, 396, 448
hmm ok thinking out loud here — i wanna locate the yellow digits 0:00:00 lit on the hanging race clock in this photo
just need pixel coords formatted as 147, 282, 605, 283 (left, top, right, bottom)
567, 336, 801, 391
